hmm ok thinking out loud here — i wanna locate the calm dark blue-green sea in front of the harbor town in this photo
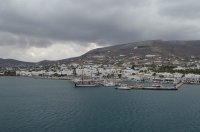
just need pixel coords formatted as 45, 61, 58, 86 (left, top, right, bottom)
0, 77, 200, 132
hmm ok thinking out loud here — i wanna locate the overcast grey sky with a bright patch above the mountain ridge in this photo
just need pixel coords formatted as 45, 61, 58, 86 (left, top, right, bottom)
0, 0, 200, 62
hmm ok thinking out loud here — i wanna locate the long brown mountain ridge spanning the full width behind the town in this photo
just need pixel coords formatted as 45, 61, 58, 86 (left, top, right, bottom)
0, 40, 200, 66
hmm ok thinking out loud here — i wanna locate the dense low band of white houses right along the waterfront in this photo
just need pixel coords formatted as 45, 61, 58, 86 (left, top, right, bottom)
16, 64, 200, 83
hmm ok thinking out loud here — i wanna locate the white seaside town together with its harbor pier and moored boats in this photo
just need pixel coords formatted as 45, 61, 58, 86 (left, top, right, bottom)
0, 55, 197, 90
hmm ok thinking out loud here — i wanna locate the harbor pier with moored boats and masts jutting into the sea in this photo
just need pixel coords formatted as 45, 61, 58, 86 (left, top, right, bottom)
73, 76, 187, 90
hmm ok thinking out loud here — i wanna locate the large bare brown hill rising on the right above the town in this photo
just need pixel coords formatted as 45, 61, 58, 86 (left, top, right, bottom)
83, 40, 200, 58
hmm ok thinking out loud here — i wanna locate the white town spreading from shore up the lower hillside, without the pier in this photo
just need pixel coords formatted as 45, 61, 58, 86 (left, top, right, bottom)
0, 54, 200, 89
